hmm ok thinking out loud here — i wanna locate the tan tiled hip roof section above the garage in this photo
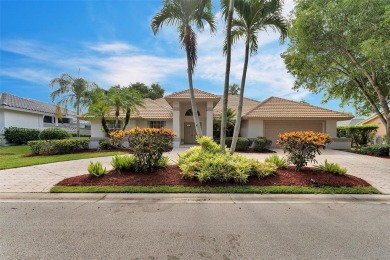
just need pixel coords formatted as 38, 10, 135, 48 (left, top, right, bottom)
244, 97, 353, 120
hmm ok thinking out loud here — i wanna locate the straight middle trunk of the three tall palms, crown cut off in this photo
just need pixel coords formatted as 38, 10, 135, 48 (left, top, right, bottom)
220, 0, 234, 153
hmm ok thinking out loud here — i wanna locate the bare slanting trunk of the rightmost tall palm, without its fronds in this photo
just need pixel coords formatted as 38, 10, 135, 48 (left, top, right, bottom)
230, 39, 249, 154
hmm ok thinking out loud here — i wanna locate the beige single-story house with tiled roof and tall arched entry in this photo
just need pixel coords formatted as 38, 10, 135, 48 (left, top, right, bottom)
91, 89, 353, 149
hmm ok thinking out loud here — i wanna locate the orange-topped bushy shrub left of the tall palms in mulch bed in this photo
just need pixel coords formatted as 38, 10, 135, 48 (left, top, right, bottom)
127, 127, 175, 172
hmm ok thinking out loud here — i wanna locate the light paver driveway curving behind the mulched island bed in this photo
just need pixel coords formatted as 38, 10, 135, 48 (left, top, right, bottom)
0, 148, 390, 194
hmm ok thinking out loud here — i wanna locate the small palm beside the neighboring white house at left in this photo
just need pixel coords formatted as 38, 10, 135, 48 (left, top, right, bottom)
49, 74, 97, 137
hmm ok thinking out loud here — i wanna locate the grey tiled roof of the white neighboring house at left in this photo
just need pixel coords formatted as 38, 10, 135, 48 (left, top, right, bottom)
0, 92, 76, 115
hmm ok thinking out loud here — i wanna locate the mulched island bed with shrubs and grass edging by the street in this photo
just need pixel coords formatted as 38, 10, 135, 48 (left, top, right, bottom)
51, 131, 379, 194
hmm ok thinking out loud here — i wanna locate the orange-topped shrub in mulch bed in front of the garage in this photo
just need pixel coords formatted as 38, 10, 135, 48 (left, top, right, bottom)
277, 131, 331, 171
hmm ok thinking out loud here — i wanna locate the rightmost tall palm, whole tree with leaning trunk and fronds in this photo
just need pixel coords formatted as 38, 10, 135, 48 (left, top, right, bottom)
224, 0, 287, 154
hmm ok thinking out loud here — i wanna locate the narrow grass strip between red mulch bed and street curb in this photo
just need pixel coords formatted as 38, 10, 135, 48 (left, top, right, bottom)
50, 186, 380, 194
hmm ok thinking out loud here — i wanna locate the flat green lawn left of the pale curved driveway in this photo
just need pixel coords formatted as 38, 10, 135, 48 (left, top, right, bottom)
0, 145, 118, 170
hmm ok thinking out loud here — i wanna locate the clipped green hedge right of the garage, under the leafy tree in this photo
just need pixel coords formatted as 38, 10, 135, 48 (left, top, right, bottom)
337, 125, 378, 146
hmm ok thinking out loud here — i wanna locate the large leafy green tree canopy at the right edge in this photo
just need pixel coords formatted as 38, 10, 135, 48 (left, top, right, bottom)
282, 0, 390, 141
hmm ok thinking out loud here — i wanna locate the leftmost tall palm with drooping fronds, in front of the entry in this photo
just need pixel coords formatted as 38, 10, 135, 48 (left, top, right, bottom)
151, 0, 216, 136
